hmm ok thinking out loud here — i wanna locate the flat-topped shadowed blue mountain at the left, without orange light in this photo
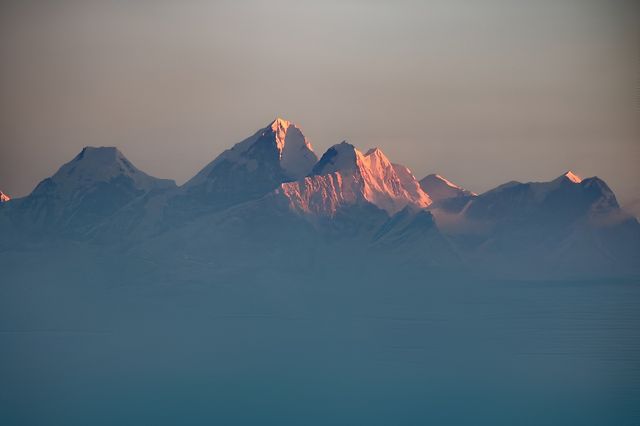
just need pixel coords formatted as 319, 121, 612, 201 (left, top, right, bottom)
12, 147, 176, 231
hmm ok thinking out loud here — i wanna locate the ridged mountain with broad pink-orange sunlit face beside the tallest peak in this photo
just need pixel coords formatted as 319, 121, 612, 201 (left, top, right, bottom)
277, 142, 431, 217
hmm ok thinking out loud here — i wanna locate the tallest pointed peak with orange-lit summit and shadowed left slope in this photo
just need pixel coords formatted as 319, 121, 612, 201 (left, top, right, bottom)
182, 118, 318, 207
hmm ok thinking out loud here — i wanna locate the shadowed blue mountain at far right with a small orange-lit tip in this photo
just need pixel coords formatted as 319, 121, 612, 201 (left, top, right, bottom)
422, 172, 640, 274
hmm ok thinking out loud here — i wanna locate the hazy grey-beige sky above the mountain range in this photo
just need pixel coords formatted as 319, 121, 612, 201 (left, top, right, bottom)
0, 0, 640, 210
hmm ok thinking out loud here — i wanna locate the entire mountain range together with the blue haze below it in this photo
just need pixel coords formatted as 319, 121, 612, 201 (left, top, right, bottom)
0, 118, 640, 425
